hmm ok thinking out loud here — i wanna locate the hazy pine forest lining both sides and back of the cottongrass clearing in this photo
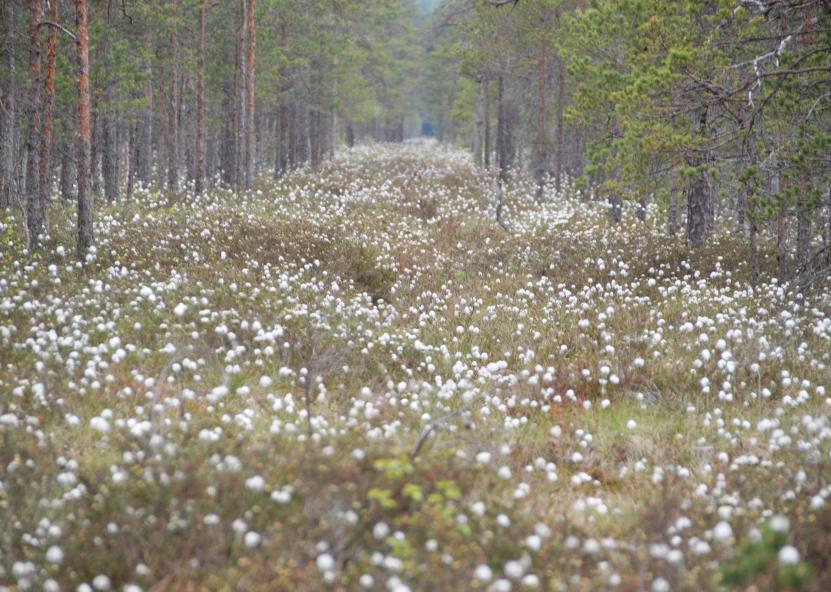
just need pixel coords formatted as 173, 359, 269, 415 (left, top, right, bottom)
0, 0, 831, 289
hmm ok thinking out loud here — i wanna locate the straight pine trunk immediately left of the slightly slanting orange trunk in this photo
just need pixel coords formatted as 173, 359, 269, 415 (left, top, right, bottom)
26, 0, 44, 247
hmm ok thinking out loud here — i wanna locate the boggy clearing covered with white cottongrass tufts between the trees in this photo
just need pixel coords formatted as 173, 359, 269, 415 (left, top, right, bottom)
0, 142, 831, 592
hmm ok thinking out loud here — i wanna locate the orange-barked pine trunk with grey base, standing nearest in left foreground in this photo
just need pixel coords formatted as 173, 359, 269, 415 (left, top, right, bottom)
75, 0, 94, 261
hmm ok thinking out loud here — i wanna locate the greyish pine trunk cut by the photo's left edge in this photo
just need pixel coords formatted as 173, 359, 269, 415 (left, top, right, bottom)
0, 2, 17, 207
